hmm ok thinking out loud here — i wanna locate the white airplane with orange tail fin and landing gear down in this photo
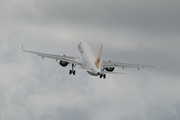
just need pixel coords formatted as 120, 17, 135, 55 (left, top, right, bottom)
21, 41, 162, 79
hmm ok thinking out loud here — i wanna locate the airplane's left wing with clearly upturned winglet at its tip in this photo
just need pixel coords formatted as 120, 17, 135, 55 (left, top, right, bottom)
21, 45, 82, 66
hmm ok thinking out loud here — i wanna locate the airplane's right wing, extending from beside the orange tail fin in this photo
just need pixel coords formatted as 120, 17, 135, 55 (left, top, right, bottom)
102, 61, 162, 69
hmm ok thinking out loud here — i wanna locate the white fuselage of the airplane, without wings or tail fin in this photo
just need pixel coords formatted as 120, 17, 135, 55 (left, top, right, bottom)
78, 41, 101, 75
